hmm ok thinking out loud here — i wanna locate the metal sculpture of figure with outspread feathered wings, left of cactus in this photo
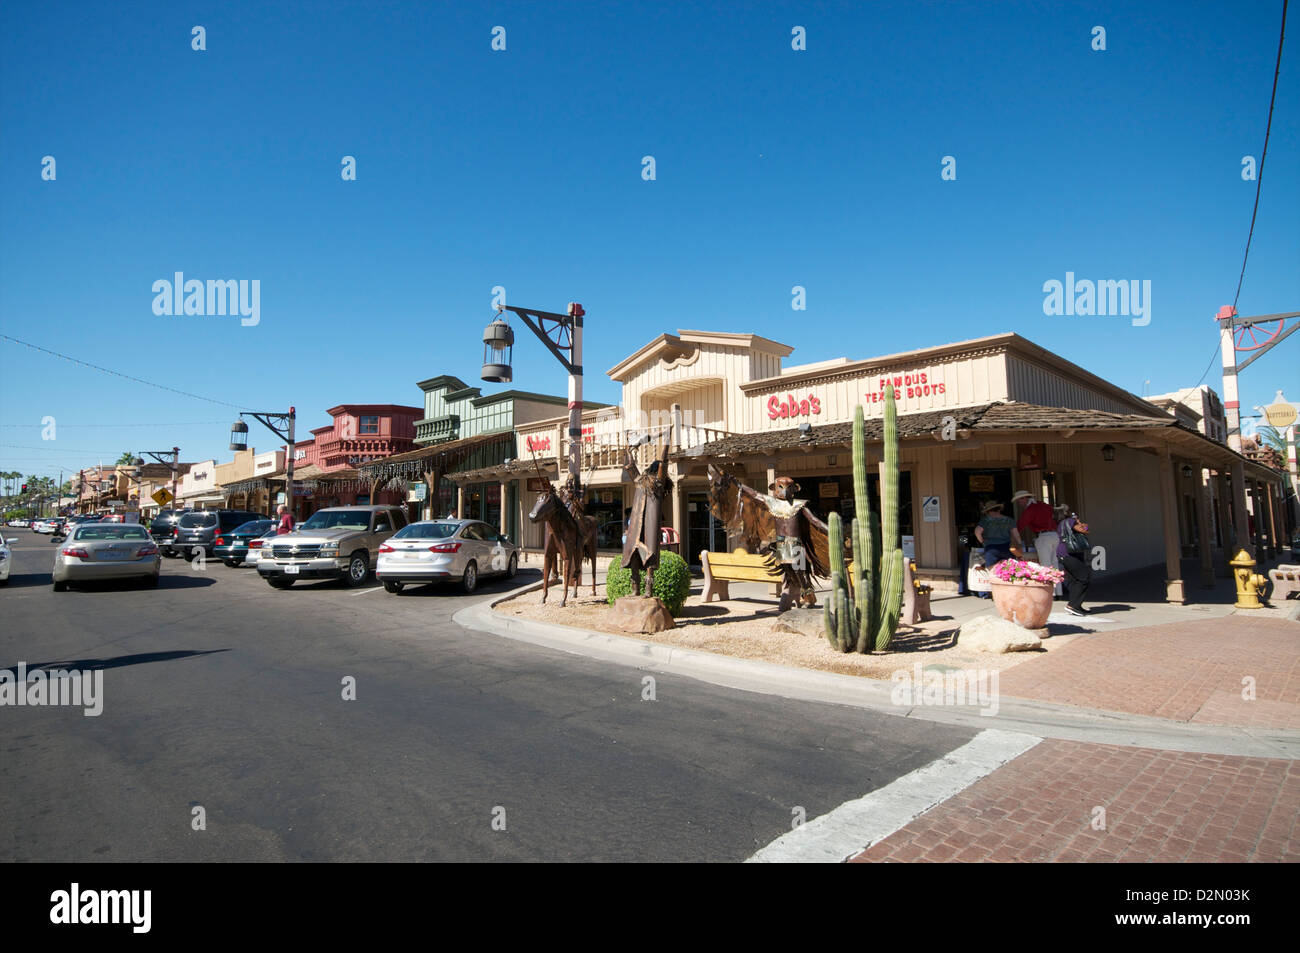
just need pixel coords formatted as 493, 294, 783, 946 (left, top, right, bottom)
709, 465, 831, 612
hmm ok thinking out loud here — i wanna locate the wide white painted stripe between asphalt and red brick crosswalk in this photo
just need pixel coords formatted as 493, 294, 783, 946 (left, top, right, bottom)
746, 728, 1043, 863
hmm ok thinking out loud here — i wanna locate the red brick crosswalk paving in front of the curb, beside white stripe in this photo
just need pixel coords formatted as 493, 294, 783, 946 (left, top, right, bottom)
854, 740, 1300, 863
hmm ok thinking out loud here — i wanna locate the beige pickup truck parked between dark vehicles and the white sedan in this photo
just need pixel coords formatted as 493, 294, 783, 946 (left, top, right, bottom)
257, 506, 407, 589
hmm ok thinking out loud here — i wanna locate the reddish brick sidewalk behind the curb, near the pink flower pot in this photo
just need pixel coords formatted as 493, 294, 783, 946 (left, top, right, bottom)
1000, 615, 1300, 729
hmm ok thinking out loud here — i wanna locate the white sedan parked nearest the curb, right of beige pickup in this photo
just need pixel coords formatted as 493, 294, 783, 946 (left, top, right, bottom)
374, 520, 519, 593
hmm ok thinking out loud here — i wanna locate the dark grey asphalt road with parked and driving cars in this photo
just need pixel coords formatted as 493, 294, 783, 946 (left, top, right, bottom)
0, 529, 974, 862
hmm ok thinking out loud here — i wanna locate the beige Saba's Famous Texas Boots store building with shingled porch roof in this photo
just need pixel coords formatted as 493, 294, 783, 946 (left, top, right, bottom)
455, 330, 1284, 601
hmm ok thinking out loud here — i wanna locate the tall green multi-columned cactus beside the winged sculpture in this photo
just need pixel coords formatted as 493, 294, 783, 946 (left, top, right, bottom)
823, 385, 904, 653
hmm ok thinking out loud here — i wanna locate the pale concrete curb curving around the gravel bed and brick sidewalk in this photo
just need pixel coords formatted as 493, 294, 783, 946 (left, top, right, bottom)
452, 582, 1300, 761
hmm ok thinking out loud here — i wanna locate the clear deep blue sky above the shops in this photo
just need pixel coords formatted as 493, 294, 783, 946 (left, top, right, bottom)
0, 0, 1300, 475
